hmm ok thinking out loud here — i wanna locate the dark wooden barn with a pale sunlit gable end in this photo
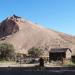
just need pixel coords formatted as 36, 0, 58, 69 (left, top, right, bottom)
49, 48, 72, 61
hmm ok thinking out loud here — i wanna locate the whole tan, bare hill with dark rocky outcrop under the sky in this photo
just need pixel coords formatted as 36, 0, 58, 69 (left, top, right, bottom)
0, 15, 75, 53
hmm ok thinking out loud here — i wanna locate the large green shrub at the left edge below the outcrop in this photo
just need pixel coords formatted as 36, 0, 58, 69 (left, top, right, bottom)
0, 43, 15, 60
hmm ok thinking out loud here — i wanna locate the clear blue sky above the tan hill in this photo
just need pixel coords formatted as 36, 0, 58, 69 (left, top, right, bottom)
0, 0, 75, 35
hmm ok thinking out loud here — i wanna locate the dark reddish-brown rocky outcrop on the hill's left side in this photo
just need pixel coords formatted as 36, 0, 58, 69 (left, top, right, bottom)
0, 15, 19, 36
